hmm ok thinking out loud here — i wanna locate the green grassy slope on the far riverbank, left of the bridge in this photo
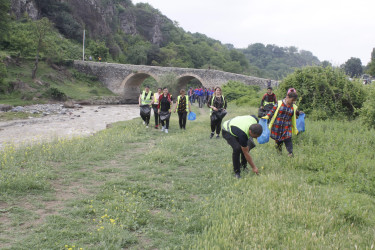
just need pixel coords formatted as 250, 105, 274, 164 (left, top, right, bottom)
0, 60, 114, 106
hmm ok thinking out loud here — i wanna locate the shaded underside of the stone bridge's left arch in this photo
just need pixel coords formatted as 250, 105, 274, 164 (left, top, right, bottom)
120, 72, 159, 103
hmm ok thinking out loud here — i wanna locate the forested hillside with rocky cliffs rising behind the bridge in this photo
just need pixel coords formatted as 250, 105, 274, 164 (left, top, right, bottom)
0, 0, 320, 79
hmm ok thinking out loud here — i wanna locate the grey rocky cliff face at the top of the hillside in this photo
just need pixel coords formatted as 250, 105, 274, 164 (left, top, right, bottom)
11, 0, 173, 46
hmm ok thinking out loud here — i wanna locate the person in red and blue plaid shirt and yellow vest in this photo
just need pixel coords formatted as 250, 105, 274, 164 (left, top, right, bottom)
262, 89, 303, 157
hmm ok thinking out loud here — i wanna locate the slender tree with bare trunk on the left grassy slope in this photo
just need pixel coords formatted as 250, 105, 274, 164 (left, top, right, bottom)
31, 17, 52, 79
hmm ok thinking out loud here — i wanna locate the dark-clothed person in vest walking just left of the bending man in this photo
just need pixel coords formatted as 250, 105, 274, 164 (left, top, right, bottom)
207, 87, 227, 139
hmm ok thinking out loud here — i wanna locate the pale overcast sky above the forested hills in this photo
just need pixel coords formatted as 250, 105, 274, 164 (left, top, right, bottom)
133, 0, 375, 66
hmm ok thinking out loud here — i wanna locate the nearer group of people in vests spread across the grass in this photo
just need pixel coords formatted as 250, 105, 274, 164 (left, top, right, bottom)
139, 86, 303, 178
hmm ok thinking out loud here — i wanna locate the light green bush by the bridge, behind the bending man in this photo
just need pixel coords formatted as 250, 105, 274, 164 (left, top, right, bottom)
222, 81, 261, 106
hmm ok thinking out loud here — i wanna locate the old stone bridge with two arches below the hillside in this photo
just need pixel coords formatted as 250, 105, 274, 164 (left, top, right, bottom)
74, 61, 276, 104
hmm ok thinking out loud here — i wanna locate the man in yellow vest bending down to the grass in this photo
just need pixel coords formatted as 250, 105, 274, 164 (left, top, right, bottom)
222, 115, 263, 178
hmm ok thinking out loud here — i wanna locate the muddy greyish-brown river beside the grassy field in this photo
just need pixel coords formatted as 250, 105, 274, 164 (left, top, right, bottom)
0, 105, 139, 150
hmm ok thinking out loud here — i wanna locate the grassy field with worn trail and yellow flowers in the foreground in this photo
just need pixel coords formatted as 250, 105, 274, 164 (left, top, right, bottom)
0, 103, 375, 249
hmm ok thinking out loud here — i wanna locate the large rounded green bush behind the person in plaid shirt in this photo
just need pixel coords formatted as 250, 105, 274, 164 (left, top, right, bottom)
277, 66, 366, 120
